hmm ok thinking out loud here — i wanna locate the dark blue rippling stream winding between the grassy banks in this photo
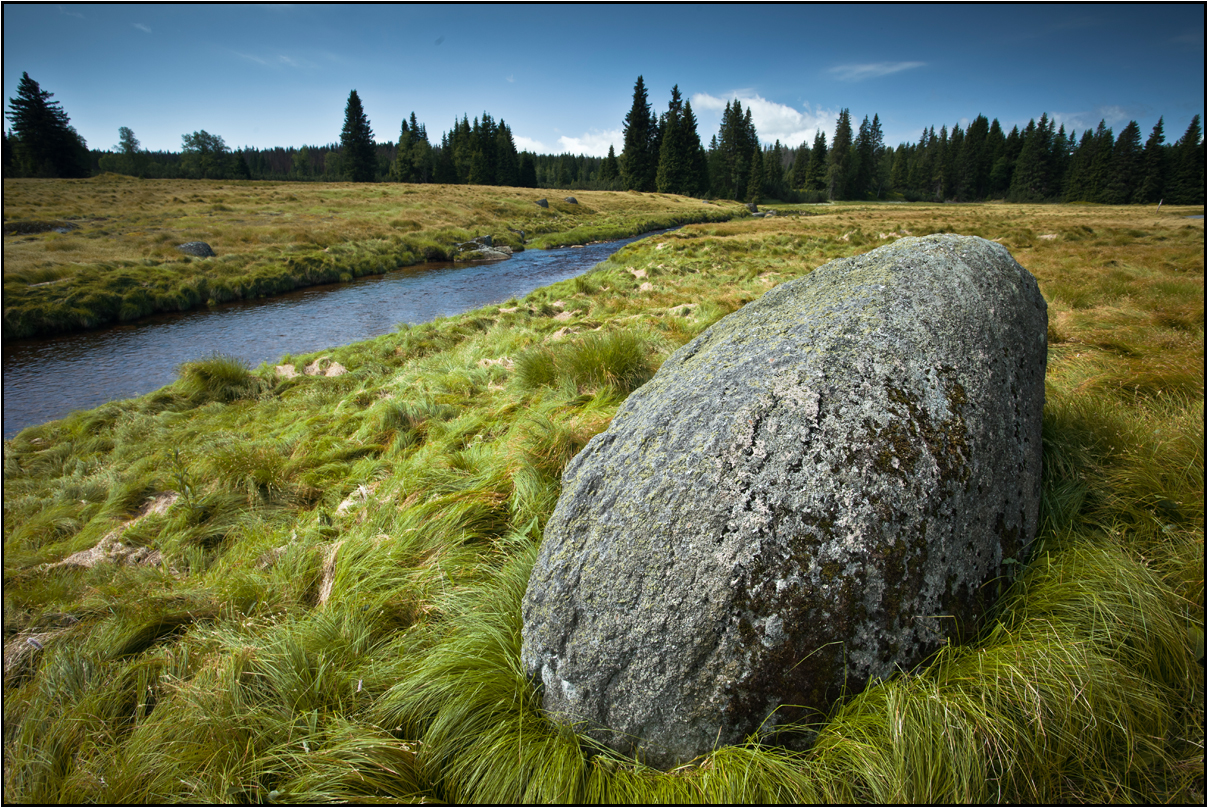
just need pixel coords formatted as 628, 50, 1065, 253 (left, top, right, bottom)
4, 231, 664, 440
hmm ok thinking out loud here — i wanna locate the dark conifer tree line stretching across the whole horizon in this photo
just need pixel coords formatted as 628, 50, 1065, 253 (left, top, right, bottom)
4, 74, 1204, 204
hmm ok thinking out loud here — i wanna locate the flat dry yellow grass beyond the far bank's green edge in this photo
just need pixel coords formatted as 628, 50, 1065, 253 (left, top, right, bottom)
4, 174, 734, 277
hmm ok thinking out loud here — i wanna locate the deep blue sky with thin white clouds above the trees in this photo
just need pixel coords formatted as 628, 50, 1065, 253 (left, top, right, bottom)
4, 4, 1204, 155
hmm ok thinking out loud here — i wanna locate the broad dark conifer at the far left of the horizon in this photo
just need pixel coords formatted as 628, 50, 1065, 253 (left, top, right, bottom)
5, 72, 91, 178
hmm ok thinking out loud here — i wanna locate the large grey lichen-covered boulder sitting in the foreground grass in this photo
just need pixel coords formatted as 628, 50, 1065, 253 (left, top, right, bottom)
522, 236, 1047, 767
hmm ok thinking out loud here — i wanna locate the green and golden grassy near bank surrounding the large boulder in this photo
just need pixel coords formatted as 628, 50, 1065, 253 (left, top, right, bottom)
4, 205, 1204, 803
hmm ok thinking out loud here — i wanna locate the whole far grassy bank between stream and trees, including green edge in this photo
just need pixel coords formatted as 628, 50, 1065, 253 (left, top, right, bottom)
4, 174, 745, 337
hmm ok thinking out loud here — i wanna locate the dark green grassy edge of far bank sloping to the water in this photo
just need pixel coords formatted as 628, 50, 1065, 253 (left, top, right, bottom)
2, 203, 749, 339
